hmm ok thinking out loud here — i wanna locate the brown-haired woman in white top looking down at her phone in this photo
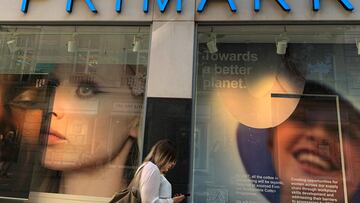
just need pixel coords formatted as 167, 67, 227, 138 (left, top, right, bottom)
139, 140, 185, 203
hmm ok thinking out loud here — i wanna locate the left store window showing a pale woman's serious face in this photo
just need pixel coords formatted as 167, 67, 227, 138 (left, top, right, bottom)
0, 26, 149, 199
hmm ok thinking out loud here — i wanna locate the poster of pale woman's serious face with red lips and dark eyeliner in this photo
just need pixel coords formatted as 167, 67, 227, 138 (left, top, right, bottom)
34, 64, 146, 197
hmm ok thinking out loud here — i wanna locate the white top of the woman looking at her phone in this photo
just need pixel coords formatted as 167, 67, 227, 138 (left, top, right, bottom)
139, 161, 173, 203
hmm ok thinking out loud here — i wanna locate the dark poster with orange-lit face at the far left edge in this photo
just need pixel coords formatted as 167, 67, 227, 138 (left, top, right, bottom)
0, 74, 49, 201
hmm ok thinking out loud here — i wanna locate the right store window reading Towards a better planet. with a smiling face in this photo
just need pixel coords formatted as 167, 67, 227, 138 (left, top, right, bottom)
192, 25, 360, 203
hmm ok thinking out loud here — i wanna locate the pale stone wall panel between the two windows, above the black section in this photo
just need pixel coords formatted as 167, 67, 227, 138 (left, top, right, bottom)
147, 21, 195, 98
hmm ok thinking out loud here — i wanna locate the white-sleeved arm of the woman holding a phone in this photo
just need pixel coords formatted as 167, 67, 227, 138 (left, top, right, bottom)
139, 163, 173, 203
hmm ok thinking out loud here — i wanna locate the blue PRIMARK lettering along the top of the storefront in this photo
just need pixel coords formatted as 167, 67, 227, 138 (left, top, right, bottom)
21, 0, 354, 13
